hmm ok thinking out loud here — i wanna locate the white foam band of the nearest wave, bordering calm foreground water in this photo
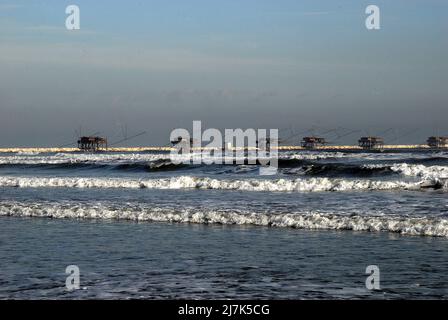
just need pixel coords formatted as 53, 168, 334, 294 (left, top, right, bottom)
0, 202, 448, 237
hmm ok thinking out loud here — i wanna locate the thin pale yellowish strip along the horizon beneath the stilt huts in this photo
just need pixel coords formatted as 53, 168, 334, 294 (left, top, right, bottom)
0, 144, 437, 153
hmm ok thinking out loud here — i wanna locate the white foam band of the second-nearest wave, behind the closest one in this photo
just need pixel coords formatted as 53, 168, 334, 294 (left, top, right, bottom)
0, 176, 440, 192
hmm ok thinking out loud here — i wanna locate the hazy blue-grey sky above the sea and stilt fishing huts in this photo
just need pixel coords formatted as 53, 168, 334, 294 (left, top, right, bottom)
0, 0, 448, 147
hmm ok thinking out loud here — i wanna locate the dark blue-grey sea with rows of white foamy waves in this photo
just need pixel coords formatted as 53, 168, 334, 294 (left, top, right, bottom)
0, 150, 448, 299
